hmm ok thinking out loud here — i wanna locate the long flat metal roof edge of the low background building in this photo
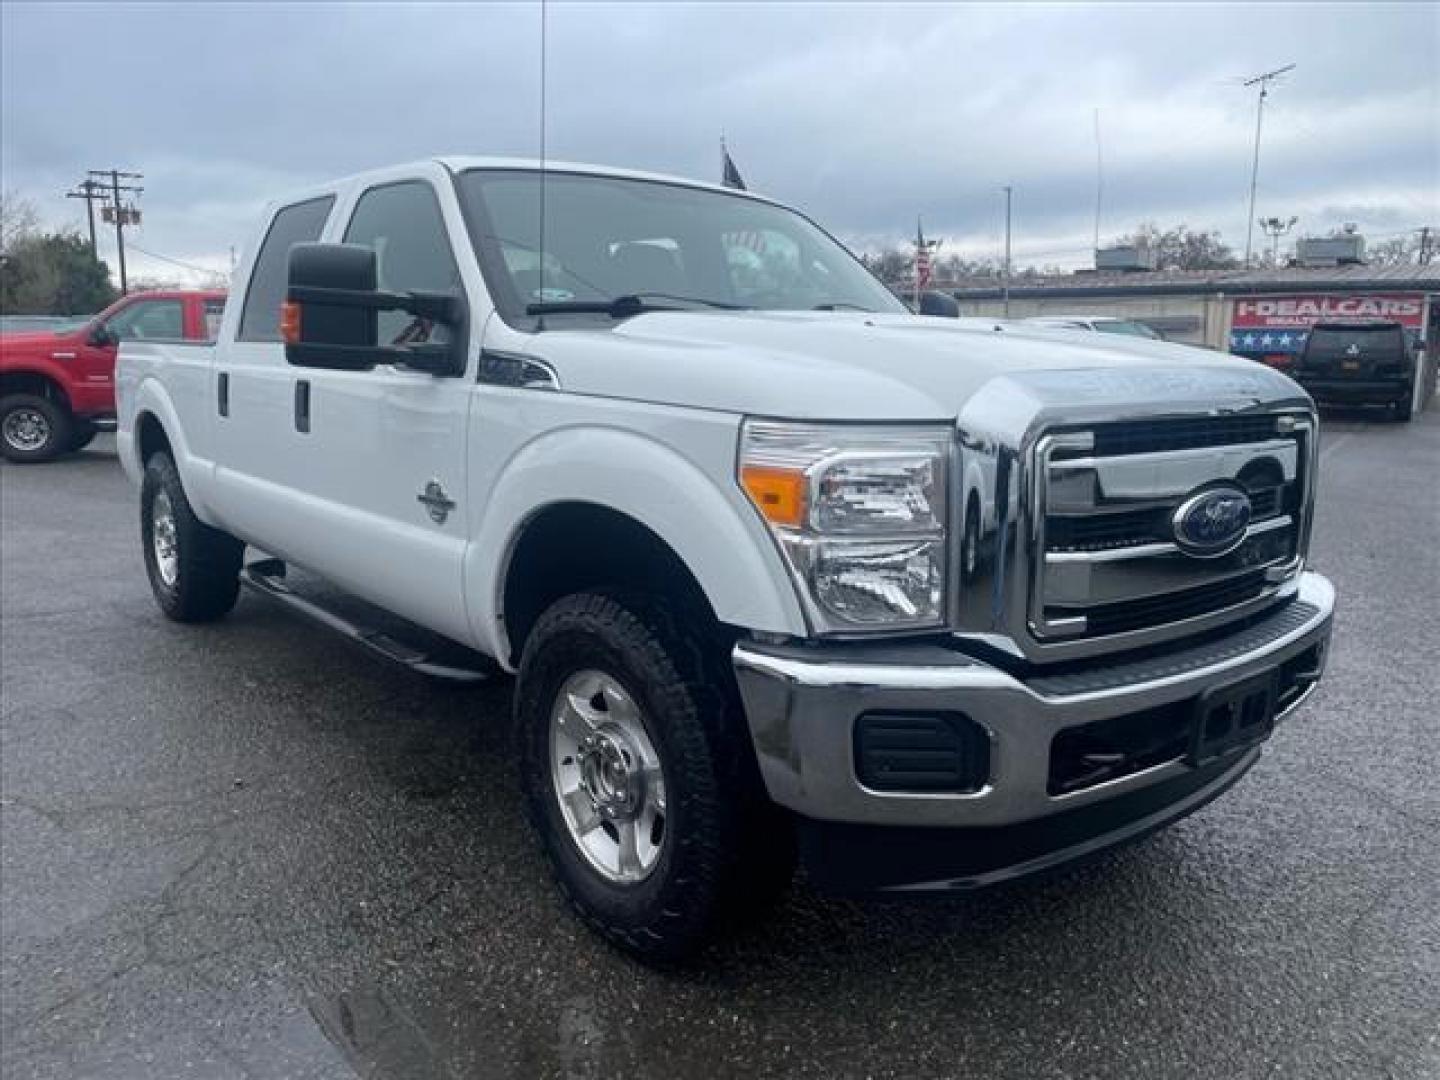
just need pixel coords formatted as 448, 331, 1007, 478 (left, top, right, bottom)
935, 262, 1440, 300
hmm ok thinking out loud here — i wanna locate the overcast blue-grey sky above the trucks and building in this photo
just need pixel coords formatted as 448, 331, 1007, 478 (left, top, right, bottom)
0, 0, 1440, 278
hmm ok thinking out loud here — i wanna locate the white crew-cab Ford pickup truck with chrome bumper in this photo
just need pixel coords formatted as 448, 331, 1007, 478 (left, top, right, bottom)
117, 158, 1333, 959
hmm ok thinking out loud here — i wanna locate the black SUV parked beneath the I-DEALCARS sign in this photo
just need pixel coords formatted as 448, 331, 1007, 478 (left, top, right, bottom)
1290, 321, 1416, 420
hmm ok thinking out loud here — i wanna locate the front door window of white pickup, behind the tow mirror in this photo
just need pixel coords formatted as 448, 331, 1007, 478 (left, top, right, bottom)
346, 180, 459, 346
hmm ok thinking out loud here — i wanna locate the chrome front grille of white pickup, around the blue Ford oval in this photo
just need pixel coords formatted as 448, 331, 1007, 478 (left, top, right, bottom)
1028, 413, 1312, 645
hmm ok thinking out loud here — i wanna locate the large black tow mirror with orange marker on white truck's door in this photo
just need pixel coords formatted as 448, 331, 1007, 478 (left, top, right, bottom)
288, 243, 465, 374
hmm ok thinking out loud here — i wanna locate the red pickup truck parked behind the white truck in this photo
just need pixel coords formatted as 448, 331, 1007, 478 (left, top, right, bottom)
0, 291, 225, 462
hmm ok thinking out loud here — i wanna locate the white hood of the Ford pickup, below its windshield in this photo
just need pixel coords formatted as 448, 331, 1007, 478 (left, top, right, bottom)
524, 311, 1305, 420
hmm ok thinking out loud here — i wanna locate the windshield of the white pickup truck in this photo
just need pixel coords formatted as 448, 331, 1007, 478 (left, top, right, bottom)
458, 170, 904, 325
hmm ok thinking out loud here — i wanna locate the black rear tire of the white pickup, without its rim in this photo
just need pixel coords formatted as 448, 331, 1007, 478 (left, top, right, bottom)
140, 452, 245, 622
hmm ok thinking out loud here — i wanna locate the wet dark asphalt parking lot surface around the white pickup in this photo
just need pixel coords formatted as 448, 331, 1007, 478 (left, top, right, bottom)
0, 410, 1440, 1080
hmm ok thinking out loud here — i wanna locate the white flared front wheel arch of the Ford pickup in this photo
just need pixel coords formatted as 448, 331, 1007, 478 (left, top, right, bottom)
465, 426, 805, 657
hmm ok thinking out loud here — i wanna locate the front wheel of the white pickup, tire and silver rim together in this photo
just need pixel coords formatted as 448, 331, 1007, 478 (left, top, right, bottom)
516, 592, 793, 960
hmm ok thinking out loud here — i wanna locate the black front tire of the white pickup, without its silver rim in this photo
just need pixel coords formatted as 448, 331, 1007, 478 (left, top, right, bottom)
516, 592, 795, 962
